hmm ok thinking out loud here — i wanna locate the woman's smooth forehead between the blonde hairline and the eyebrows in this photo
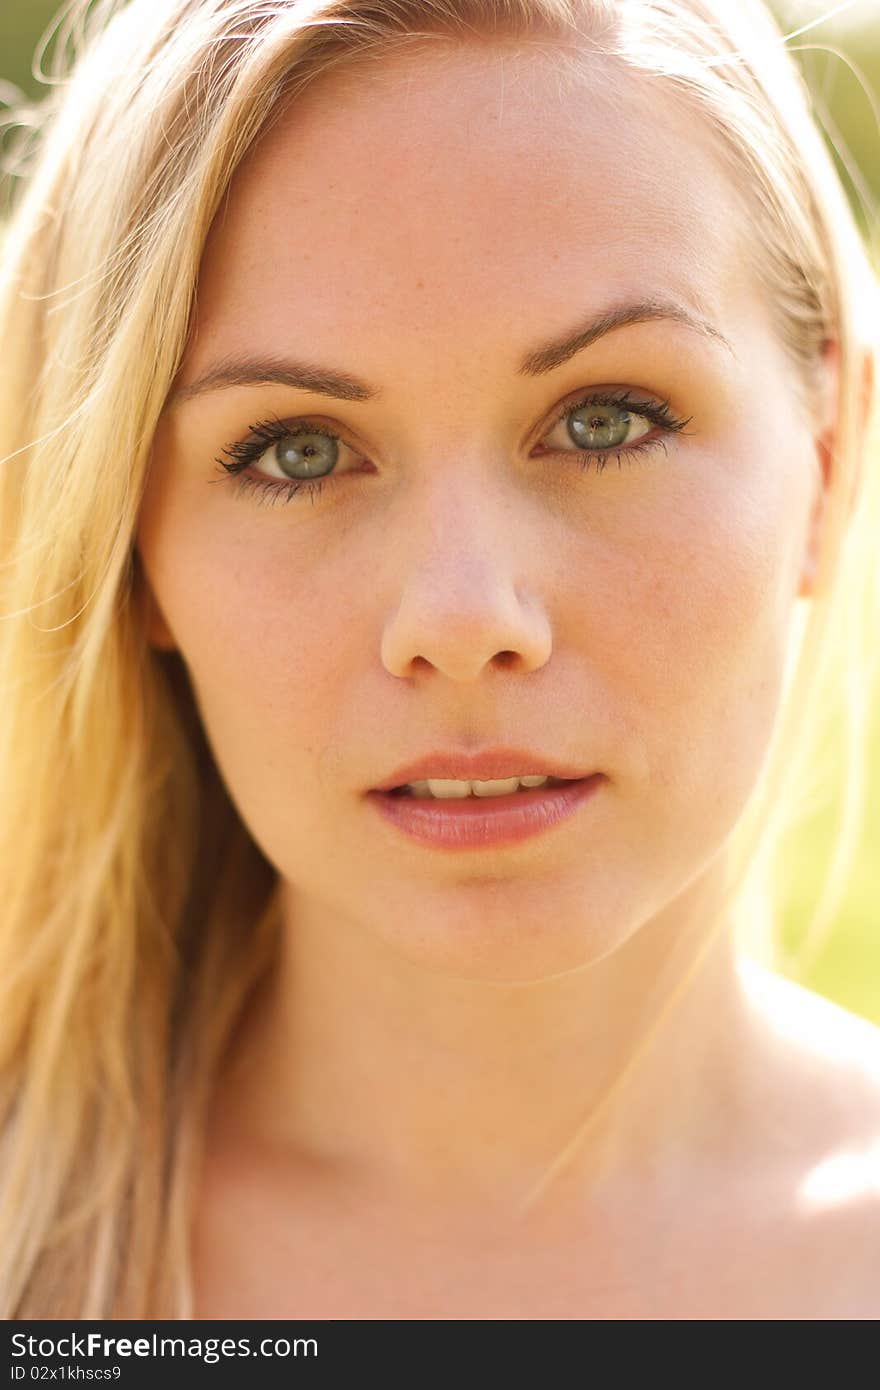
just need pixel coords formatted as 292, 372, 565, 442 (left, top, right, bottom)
190, 40, 742, 359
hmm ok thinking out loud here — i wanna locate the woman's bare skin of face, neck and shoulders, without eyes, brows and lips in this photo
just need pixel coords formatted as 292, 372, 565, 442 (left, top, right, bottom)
138, 40, 880, 1318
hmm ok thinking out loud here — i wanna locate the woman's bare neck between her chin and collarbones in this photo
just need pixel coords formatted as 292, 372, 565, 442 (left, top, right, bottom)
211, 850, 738, 1213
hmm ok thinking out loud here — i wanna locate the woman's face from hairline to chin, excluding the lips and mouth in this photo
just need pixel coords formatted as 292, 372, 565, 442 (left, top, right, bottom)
138, 44, 819, 980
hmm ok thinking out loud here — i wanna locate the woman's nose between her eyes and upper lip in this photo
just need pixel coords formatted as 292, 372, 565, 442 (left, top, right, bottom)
381, 484, 552, 684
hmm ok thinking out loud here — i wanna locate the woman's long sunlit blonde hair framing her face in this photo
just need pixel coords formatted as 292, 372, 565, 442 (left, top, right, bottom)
0, 0, 879, 1319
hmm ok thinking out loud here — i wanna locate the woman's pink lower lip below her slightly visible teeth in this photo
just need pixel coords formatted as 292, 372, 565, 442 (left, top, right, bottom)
367, 773, 605, 849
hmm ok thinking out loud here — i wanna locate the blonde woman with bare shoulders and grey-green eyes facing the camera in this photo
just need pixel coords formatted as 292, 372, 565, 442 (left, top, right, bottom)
0, 0, 880, 1319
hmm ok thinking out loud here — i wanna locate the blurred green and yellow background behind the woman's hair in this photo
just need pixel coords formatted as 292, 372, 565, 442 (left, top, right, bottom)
0, 0, 880, 1023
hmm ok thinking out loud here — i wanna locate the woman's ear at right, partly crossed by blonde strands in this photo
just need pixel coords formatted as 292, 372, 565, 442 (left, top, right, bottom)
798, 339, 874, 598
